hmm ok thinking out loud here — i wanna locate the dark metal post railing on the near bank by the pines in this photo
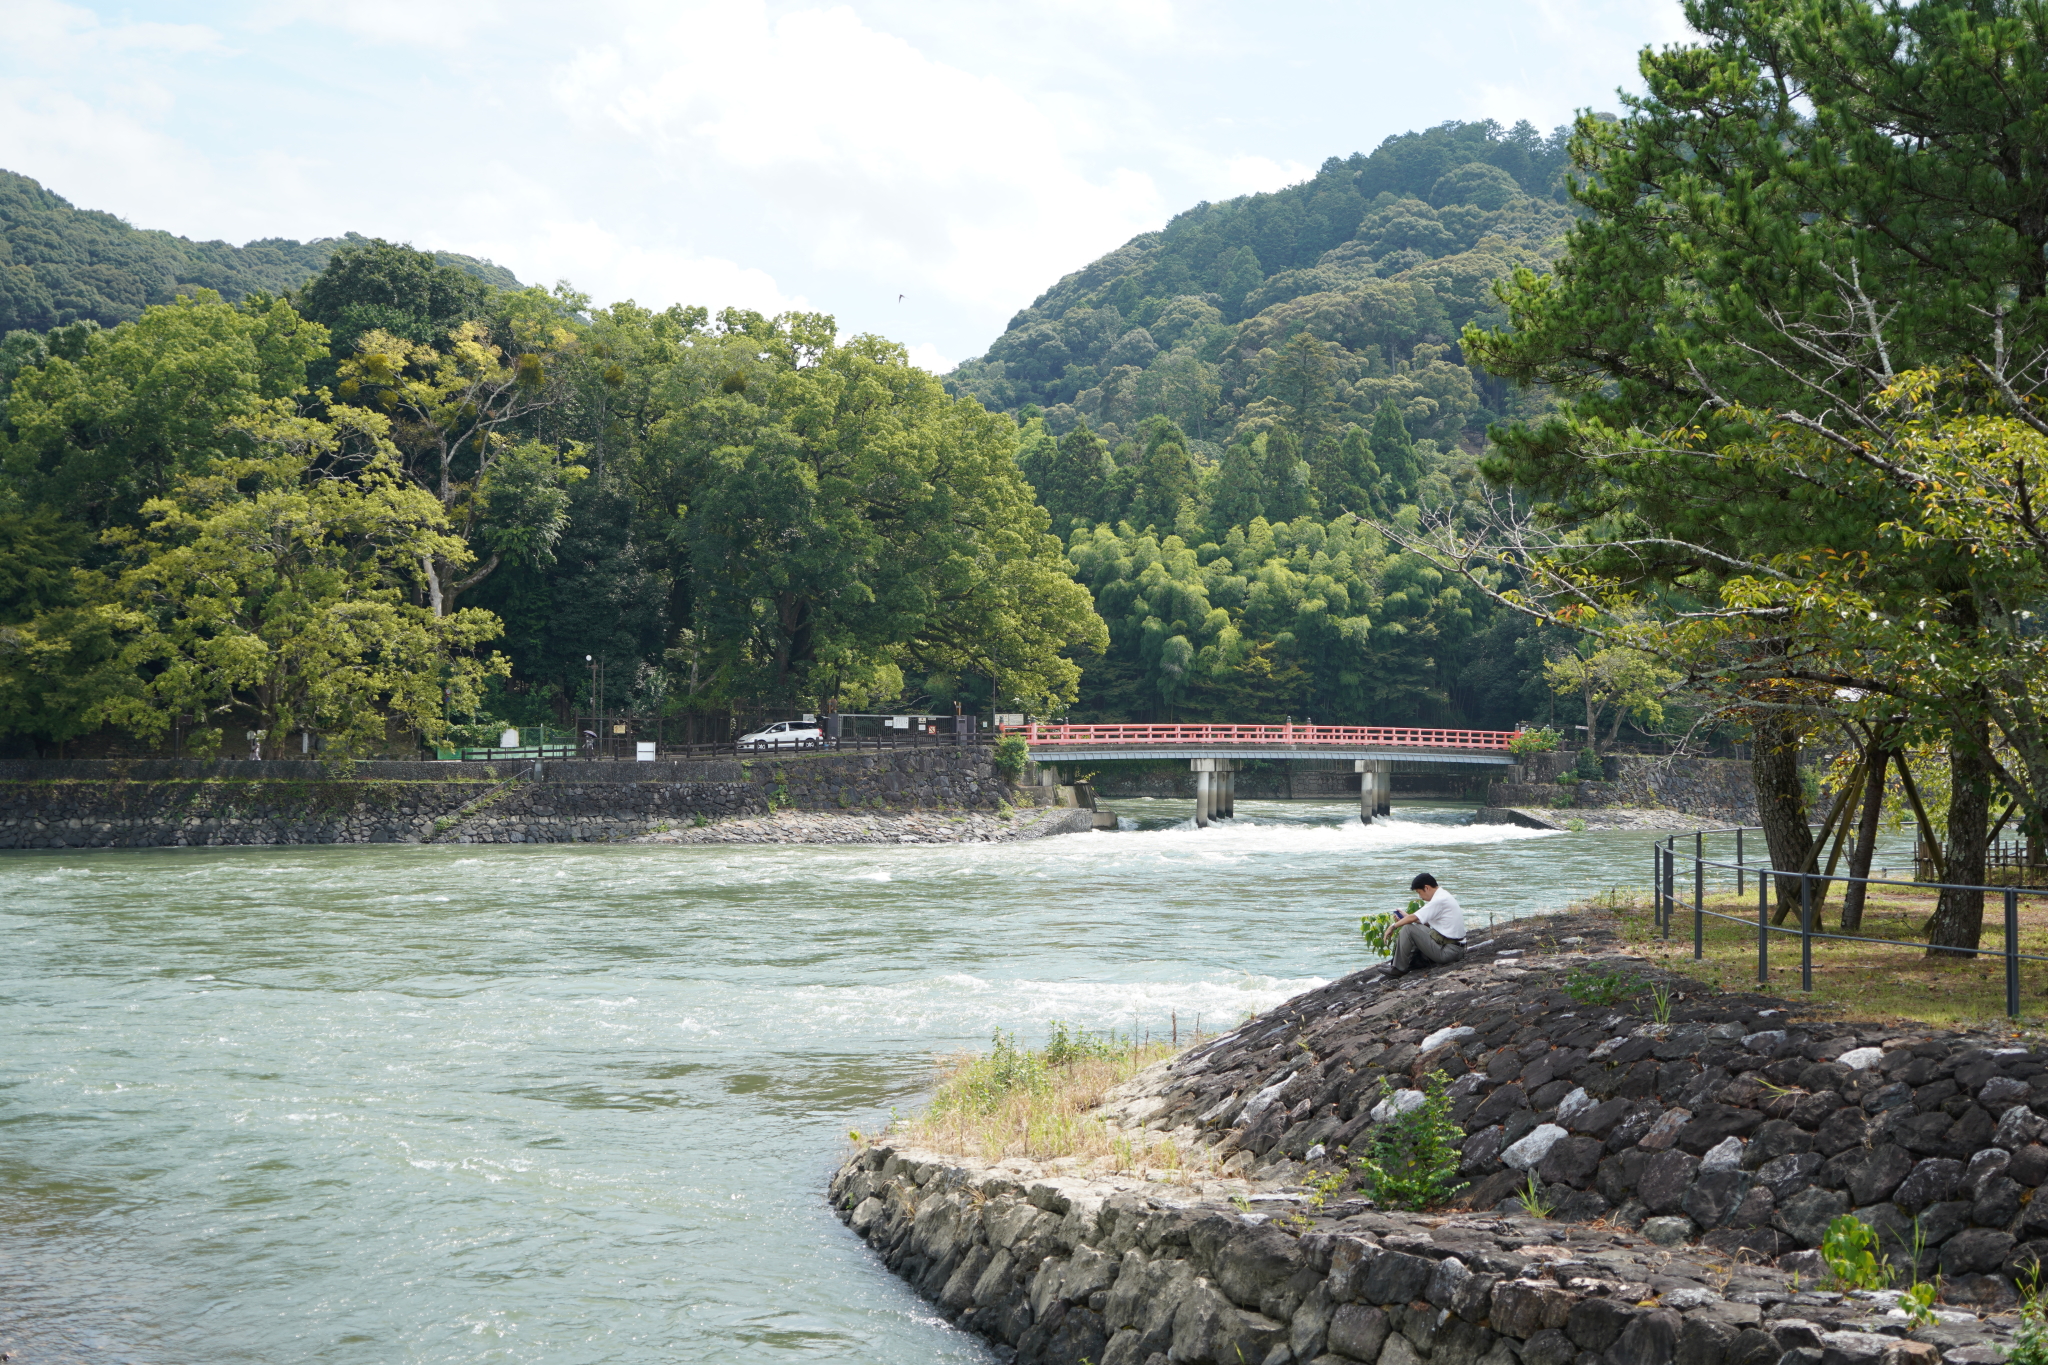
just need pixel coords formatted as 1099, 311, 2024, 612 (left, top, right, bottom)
1651, 825, 2048, 1019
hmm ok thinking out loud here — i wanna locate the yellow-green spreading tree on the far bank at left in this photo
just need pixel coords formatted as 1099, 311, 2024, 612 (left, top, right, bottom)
88, 403, 500, 757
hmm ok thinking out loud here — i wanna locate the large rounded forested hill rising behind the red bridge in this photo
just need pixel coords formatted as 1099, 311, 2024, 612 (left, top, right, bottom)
948, 121, 1573, 458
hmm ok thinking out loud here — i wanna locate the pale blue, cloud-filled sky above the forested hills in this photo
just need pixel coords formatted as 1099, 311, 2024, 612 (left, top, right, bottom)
0, 0, 1686, 370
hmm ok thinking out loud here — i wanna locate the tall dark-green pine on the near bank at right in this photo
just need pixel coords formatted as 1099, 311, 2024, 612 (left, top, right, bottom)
1474, 0, 2048, 948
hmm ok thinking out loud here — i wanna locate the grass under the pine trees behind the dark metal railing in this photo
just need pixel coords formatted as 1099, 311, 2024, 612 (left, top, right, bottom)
1597, 878, 2048, 1029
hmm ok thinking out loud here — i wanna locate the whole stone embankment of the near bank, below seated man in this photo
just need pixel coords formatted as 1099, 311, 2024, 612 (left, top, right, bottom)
831, 921, 2048, 1365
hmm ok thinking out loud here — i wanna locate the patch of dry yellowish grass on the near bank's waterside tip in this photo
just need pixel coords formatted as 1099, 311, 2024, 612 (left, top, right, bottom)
891, 1021, 1212, 1181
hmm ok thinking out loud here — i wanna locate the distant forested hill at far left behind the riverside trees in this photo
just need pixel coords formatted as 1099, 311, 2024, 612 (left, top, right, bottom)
0, 170, 520, 334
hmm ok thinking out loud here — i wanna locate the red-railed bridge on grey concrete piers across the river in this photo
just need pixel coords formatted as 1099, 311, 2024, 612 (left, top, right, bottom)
1004, 722, 1520, 825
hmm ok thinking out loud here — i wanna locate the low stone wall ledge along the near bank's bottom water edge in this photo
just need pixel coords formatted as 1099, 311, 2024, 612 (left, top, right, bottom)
831, 1146, 1982, 1365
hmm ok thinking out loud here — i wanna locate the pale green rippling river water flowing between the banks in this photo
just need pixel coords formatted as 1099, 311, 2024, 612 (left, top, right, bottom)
0, 800, 1651, 1365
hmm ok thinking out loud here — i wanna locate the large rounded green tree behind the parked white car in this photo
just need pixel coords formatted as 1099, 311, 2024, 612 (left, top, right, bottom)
659, 315, 1102, 710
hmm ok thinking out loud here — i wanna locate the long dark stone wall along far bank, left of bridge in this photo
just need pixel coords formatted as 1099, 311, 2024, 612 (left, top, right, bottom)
0, 749, 1040, 849
